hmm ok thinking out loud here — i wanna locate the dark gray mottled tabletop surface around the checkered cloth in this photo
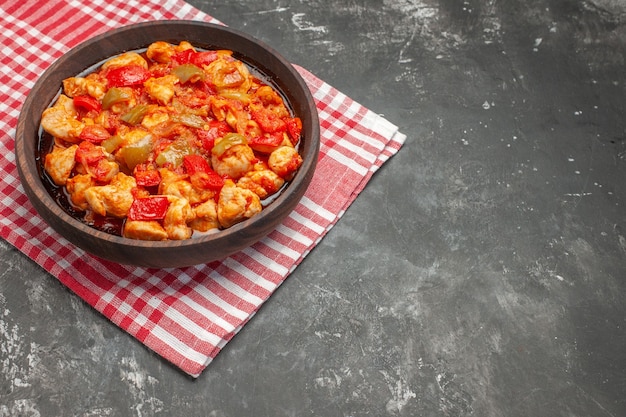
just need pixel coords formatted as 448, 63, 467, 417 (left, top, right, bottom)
0, 0, 626, 417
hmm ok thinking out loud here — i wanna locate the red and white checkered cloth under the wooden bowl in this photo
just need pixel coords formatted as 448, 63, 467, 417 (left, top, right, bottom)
0, 0, 405, 377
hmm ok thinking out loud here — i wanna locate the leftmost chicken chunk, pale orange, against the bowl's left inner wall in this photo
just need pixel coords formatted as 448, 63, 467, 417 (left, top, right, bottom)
41, 94, 85, 143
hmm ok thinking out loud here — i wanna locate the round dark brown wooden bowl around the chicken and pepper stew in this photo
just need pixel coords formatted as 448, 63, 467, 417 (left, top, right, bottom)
15, 21, 320, 268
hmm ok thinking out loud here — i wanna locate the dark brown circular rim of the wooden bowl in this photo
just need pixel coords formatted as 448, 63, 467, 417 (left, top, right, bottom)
15, 20, 320, 256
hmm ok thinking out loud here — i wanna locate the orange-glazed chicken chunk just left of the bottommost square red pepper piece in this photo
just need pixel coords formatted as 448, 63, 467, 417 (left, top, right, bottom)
85, 172, 137, 218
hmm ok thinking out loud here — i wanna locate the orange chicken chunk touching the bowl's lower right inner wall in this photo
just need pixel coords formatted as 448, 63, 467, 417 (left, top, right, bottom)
217, 180, 263, 228
